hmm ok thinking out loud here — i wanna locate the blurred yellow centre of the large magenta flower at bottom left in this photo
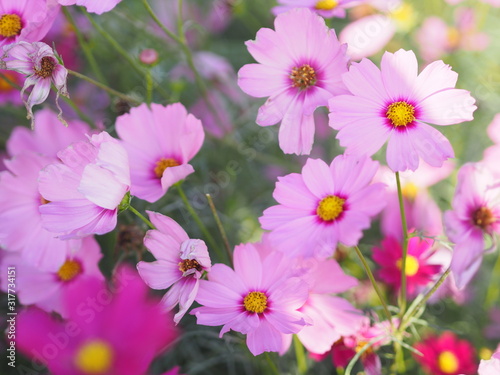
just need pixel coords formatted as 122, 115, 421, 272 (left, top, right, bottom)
75, 340, 113, 375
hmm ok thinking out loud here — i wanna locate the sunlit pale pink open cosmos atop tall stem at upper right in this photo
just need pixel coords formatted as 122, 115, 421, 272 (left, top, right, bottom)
329, 50, 476, 172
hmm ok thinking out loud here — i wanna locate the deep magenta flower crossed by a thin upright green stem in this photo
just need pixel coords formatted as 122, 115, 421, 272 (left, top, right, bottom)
373, 237, 442, 296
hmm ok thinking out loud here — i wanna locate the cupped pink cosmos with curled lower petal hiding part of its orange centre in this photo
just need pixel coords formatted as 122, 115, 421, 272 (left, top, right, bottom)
116, 103, 205, 202
